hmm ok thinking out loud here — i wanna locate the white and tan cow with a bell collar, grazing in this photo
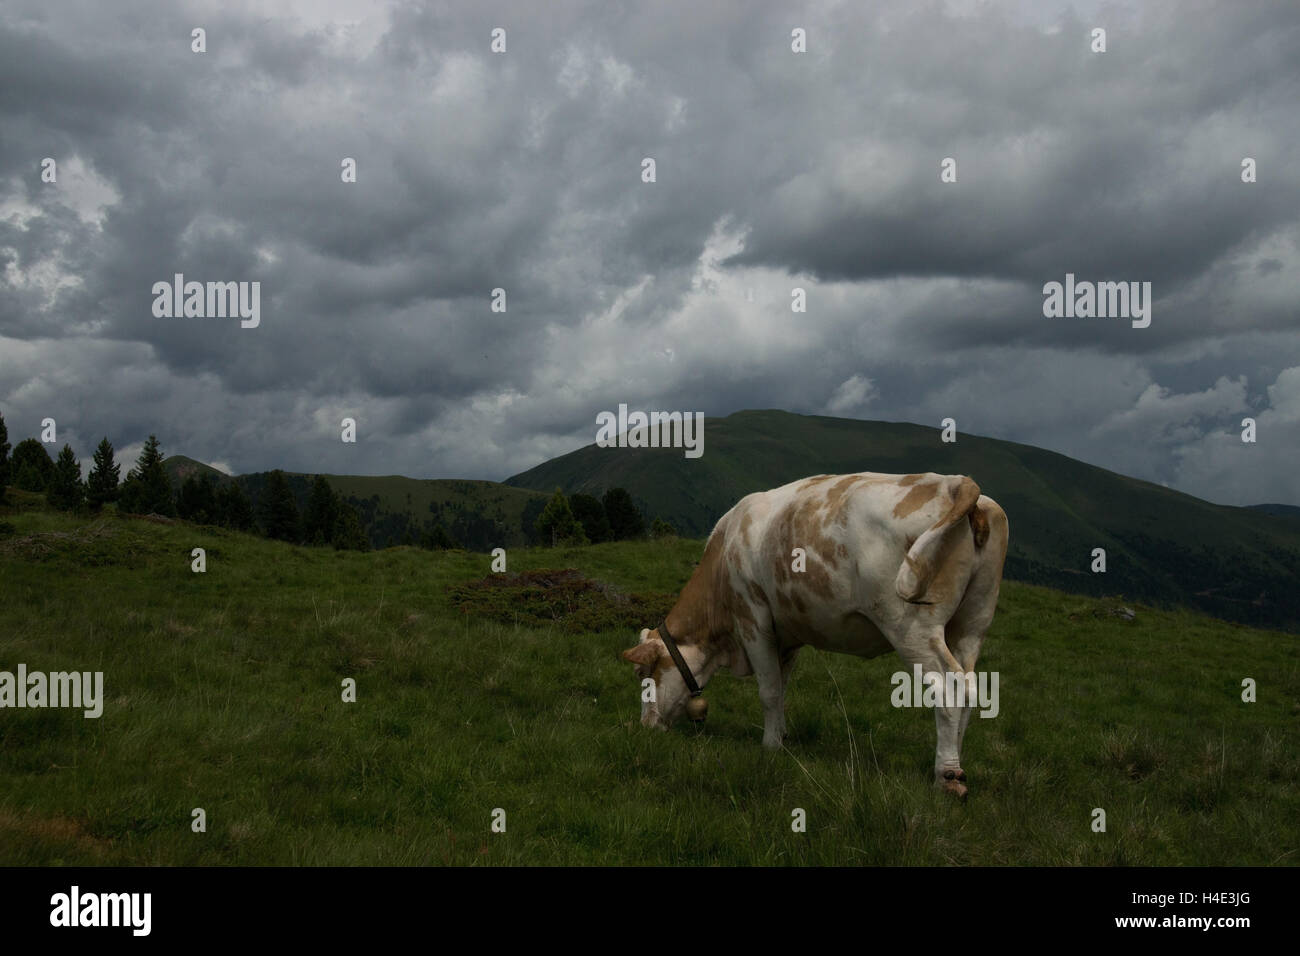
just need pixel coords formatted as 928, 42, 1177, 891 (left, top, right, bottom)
623, 472, 1008, 799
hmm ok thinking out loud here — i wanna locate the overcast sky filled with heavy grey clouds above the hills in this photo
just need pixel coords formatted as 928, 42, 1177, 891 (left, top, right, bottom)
0, 0, 1300, 505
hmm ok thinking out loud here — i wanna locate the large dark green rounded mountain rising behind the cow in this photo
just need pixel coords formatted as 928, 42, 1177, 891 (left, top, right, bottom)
507, 411, 1300, 630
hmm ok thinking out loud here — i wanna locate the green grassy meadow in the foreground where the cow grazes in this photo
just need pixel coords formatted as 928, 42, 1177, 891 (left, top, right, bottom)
0, 494, 1300, 865
